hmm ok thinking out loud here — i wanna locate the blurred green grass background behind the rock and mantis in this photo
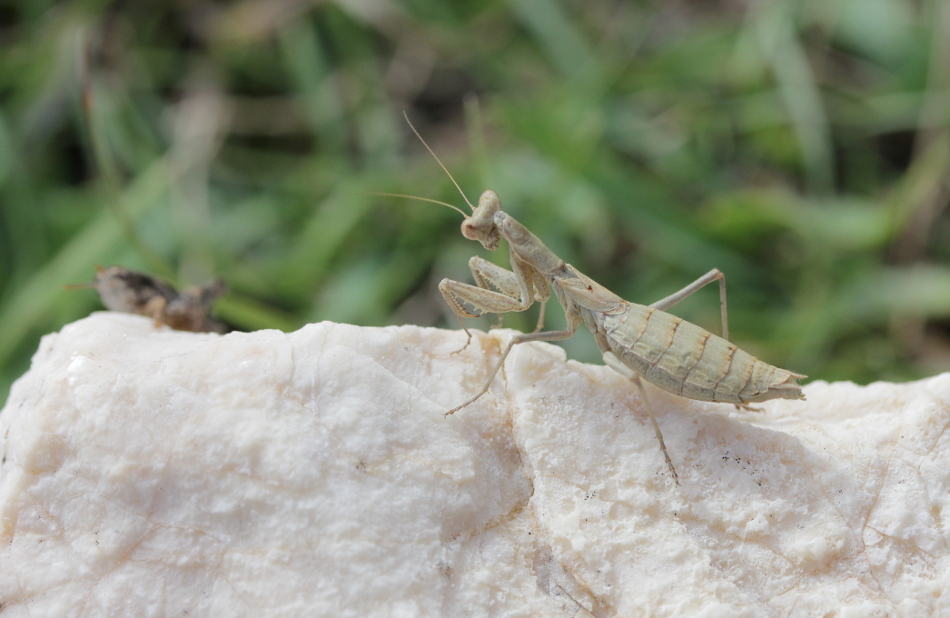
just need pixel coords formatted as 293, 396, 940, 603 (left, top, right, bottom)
0, 0, 950, 399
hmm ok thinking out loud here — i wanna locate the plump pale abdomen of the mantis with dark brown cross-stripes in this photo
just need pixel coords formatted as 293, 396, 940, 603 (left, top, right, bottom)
602, 303, 805, 404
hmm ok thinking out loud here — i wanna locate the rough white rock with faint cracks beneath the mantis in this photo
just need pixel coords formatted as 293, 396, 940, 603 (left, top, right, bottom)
0, 313, 950, 618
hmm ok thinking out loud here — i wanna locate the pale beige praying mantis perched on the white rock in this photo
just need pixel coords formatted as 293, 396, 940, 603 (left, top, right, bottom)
389, 116, 807, 485
